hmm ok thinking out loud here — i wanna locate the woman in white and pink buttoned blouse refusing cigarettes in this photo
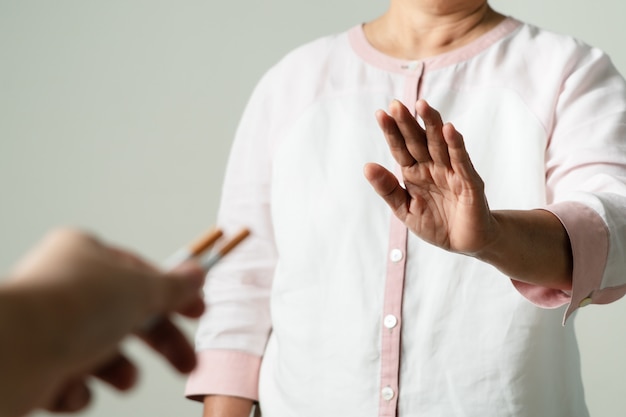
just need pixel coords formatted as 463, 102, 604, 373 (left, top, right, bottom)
187, 0, 626, 417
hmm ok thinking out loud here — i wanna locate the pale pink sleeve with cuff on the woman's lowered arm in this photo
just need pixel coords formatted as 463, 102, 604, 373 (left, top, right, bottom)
185, 66, 277, 400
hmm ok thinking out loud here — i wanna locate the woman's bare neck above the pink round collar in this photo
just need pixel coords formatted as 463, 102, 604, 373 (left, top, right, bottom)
363, 0, 505, 60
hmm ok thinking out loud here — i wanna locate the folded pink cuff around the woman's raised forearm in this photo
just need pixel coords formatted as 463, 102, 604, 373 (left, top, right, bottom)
513, 202, 608, 323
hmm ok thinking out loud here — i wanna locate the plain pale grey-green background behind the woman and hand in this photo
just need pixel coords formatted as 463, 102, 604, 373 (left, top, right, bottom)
0, 0, 626, 417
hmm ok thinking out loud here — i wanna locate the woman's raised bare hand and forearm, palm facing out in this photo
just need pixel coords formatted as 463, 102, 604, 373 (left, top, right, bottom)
364, 100, 572, 290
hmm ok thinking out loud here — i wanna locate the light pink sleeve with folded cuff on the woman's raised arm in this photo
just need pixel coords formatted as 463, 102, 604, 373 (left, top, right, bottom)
514, 47, 626, 320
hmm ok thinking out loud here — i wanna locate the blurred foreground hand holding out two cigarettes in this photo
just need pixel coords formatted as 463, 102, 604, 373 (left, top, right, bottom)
0, 229, 204, 417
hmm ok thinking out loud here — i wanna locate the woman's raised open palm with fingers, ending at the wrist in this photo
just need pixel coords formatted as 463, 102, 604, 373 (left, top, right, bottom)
365, 100, 495, 254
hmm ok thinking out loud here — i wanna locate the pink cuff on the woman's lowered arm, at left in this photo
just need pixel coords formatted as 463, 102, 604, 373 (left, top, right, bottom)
185, 350, 261, 401
